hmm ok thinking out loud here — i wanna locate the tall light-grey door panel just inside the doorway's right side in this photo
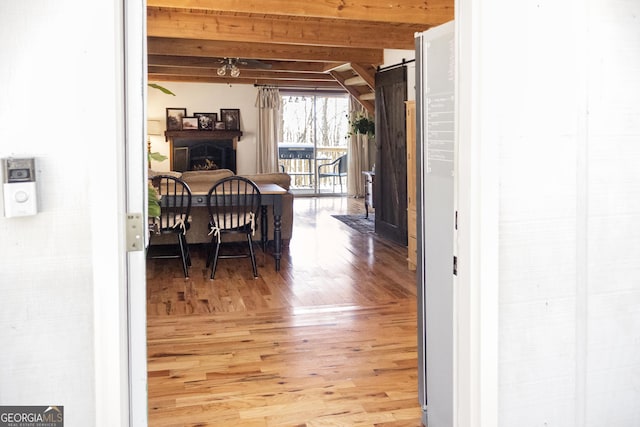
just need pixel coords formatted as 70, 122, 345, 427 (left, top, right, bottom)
416, 22, 456, 427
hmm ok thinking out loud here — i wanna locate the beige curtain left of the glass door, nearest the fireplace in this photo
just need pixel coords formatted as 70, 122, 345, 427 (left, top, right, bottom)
256, 87, 282, 173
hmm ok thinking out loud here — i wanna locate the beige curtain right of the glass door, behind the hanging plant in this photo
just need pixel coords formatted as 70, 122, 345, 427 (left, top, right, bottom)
347, 97, 371, 197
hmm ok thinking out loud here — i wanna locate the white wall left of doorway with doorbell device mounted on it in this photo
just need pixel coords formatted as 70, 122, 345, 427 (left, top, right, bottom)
0, 0, 126, 426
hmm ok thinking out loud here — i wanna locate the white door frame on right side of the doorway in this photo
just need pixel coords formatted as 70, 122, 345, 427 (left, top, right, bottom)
454, 0, 499, 427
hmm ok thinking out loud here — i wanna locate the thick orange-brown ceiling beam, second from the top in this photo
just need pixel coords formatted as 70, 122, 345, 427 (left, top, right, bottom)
147, 7, 422, 49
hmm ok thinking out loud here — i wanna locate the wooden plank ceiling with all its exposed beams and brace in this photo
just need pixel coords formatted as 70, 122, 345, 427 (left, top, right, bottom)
147, 0, 453, 112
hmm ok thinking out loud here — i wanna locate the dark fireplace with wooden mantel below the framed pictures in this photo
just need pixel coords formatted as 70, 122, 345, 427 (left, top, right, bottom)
165, 131, 242, 173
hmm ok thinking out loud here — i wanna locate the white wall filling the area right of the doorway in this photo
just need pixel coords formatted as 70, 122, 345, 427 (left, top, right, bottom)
457, 0, 640, 427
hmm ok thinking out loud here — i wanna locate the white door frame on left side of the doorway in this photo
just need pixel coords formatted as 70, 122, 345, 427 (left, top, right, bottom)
90, 0, 147, 427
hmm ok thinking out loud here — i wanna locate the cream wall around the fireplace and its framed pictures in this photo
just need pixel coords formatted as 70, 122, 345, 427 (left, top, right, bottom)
147, 82, 258, 174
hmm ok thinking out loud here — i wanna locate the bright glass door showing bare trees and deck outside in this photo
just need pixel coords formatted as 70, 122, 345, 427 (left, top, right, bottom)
279, 94, 349, 192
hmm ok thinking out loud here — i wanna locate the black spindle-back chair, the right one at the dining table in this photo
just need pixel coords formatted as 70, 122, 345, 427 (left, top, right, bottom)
206, 176, 261, 280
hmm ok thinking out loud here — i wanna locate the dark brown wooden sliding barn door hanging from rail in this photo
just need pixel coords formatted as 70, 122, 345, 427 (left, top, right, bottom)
374, 66, 407, 246
